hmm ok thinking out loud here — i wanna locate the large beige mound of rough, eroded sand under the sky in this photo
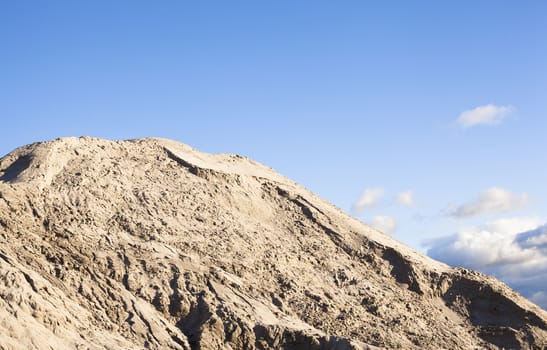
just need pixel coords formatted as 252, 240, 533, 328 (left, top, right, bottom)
0, 137, 547, 350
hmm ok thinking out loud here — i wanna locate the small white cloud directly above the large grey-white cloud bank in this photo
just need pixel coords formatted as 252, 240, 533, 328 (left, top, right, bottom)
450, 187, 529, 218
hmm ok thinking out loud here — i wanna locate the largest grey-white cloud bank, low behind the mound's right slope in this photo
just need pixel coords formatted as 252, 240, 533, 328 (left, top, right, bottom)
425, 218, 547, 310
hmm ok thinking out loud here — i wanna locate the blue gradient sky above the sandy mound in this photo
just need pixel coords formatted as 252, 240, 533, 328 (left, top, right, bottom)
0, 0, 547, 305
